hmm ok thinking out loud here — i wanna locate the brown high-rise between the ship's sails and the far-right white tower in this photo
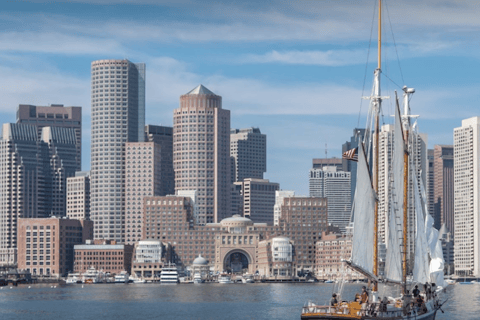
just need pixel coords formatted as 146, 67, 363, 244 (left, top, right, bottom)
432, 145, 455, 234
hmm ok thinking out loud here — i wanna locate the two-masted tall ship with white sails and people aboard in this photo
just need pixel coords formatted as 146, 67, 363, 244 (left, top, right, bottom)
301, 0, 448, 320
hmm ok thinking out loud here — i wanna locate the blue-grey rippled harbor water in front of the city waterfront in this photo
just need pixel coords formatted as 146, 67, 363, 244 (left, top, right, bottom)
0, 283, 480, 320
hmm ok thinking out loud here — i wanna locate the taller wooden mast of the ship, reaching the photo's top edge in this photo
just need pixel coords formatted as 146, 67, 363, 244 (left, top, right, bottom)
373, 0, 382, 291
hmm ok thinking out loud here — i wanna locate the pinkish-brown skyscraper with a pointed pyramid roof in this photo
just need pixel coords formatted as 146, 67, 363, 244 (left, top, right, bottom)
173, 85, 231, 224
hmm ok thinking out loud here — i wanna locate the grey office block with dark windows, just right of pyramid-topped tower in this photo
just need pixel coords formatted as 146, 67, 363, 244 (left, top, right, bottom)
230, 128, 267, 182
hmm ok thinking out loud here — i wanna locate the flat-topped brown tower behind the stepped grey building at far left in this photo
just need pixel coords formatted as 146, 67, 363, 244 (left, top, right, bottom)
17, 104, 82, 171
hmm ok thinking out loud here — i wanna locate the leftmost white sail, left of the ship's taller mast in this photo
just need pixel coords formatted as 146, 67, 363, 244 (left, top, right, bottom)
352, 143, 375, 275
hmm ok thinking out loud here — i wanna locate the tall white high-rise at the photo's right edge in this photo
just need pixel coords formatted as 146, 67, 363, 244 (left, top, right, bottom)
453, 117, 480, 277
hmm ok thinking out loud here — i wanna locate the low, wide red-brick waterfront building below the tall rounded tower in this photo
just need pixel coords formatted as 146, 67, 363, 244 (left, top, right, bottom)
74, 239, 133, 274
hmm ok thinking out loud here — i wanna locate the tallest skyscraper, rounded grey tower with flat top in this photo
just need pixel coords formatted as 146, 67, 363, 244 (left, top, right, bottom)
90, 60, 145, 243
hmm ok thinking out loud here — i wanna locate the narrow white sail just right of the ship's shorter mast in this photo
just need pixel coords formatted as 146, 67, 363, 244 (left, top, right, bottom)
412, 169, 430, 283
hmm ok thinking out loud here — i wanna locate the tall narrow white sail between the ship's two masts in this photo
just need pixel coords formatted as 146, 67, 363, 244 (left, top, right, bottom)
385, 103, 405, 281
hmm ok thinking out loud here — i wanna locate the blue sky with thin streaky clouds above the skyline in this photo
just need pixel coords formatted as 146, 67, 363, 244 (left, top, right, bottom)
0, 0, 480, 194
